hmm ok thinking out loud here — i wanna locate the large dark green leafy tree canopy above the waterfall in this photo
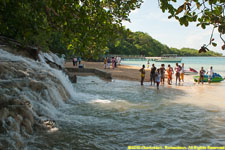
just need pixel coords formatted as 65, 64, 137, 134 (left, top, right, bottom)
0, 0, 142, 57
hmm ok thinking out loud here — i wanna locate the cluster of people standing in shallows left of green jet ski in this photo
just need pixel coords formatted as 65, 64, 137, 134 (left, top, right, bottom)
139, 63, 184, 89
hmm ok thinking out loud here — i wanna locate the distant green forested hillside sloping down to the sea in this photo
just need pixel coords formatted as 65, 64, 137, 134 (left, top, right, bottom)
108, 31, 222, 56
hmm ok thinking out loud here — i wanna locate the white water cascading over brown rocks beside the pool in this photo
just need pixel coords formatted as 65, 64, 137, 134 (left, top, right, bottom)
0, 49, 75, 149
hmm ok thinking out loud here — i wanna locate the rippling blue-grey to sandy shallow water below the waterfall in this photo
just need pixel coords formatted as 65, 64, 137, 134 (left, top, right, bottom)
28, 76, 225, 150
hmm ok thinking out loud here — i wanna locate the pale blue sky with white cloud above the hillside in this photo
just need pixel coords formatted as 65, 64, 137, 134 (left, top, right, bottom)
123, 0, 225, 56
